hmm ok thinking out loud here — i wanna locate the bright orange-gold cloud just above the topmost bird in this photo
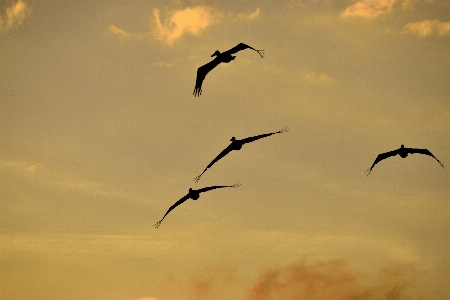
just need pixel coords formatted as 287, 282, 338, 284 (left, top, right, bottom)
153, 6, 214, 45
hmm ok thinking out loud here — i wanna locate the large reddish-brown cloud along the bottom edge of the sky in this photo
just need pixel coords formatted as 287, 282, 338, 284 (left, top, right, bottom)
248, 260, 420, 300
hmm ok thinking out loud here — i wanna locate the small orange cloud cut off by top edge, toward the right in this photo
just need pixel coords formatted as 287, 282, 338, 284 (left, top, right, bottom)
340, 0, 397, 19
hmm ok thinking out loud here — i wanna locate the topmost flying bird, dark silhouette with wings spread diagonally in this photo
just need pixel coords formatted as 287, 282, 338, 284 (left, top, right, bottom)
193, 43, 264, 97
